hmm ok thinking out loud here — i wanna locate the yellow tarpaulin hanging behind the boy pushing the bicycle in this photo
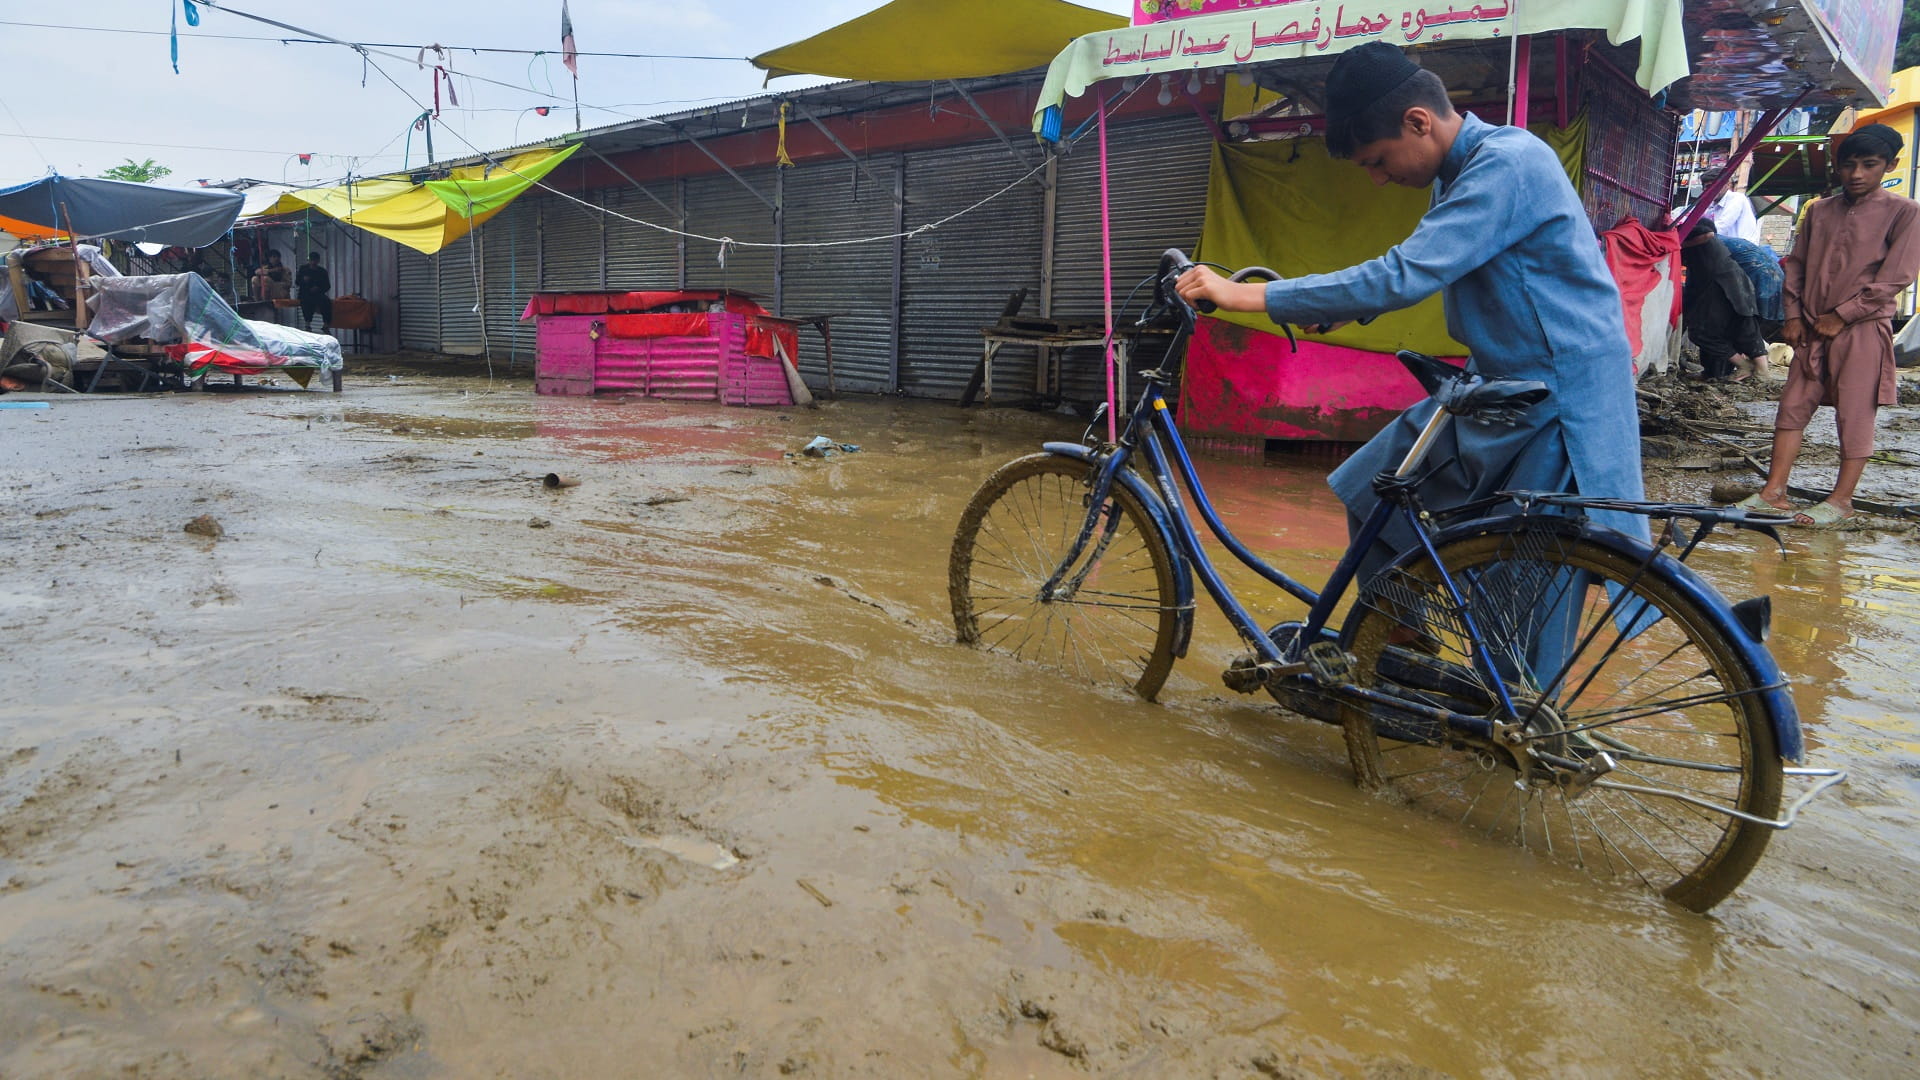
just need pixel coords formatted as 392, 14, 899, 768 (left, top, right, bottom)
1200, 117, 1597, 356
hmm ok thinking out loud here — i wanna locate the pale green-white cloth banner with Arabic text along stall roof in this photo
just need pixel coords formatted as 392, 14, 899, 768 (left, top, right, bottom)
1033, 0, 1688, 131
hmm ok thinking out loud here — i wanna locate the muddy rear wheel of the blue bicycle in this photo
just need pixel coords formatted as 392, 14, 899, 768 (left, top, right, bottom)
1344, 519, 1782, 911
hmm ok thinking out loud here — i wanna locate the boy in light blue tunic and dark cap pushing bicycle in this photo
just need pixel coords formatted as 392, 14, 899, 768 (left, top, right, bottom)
1179, 42, 1647, 580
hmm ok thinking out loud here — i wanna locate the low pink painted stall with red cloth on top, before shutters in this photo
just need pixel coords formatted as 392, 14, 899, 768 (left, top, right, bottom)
520, 288, 804, 405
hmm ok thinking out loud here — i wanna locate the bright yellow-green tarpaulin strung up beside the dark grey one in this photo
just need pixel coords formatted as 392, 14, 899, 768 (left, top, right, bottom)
253, 144, 580, 256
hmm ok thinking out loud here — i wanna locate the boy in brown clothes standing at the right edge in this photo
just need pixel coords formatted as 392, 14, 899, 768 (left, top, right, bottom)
1738, 123, 1920, 528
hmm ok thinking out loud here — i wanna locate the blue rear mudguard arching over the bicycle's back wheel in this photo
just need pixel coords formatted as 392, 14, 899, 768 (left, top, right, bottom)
1392, 513, 1805, 763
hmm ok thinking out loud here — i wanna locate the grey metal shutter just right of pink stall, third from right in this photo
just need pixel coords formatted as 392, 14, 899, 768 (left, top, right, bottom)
781, 160, 899, 394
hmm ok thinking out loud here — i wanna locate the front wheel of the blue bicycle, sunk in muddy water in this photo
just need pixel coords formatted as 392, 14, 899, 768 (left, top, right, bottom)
947, 454, 1179, 701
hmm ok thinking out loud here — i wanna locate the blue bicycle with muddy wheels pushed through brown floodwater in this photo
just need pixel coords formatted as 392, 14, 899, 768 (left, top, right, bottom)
948, 250, 1845, 911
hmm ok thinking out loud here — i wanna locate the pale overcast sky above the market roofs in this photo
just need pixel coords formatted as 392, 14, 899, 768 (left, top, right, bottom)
0, 0, 1131, 186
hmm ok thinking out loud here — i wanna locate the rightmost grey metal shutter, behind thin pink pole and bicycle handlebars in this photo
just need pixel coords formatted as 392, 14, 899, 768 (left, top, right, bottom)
1052, 117, 1213, 409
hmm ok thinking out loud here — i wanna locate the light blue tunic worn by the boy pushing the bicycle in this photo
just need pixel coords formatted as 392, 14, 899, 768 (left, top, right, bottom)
1267, 115, 1647, 563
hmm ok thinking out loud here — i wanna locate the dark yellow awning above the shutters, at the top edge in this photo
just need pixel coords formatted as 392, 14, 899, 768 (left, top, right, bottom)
753, 0, 1127, 83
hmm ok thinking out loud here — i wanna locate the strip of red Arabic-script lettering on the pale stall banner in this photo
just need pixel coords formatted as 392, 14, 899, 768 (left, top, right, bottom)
1102, 0, 1513, 69
